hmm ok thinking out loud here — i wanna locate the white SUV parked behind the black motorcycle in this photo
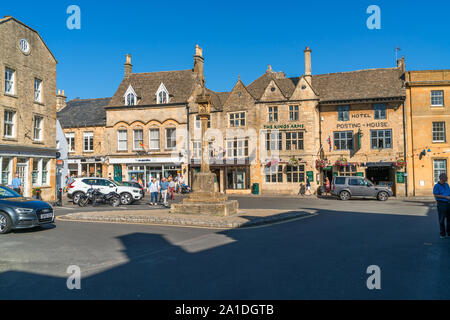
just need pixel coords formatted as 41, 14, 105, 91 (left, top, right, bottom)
67, 178, 143, 205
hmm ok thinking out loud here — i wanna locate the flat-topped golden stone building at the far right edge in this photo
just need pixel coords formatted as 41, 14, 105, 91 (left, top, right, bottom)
406, 70, 450, 196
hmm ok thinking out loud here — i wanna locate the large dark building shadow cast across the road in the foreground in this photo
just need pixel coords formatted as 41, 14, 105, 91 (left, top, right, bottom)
0, 202, 450, 299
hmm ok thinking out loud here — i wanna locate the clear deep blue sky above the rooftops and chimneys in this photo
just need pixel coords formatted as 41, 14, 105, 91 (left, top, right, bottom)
0, 0, 450, 99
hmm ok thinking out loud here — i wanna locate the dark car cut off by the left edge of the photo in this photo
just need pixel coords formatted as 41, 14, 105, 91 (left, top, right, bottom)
0, 186, 55, 234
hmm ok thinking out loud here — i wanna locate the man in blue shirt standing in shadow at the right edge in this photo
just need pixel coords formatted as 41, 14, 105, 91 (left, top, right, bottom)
433, 173, 450, 239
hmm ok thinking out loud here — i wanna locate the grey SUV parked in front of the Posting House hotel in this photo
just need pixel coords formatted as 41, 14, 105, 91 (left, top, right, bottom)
331, 177, 393, 201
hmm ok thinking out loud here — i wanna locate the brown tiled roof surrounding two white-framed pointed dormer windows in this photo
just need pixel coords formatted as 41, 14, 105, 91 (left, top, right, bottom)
109, 69, 199, 107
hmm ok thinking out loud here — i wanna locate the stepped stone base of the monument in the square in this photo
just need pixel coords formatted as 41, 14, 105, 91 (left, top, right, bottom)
170, 172, 239, 216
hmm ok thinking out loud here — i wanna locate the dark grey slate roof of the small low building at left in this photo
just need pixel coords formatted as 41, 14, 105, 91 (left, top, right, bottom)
57, 98, 111, 128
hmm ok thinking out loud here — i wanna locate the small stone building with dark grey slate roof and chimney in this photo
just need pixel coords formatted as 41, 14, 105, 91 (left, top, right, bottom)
58, 97, 111, 177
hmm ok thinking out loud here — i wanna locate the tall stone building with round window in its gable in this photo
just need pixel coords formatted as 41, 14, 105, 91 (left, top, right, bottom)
0, 16, 57, 200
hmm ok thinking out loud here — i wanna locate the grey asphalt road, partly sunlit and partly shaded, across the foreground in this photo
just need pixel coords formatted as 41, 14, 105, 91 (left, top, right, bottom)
0, 197, 450, 299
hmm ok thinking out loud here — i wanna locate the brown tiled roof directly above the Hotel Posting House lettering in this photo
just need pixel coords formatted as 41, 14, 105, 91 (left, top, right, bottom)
312, 68, 406, 102
